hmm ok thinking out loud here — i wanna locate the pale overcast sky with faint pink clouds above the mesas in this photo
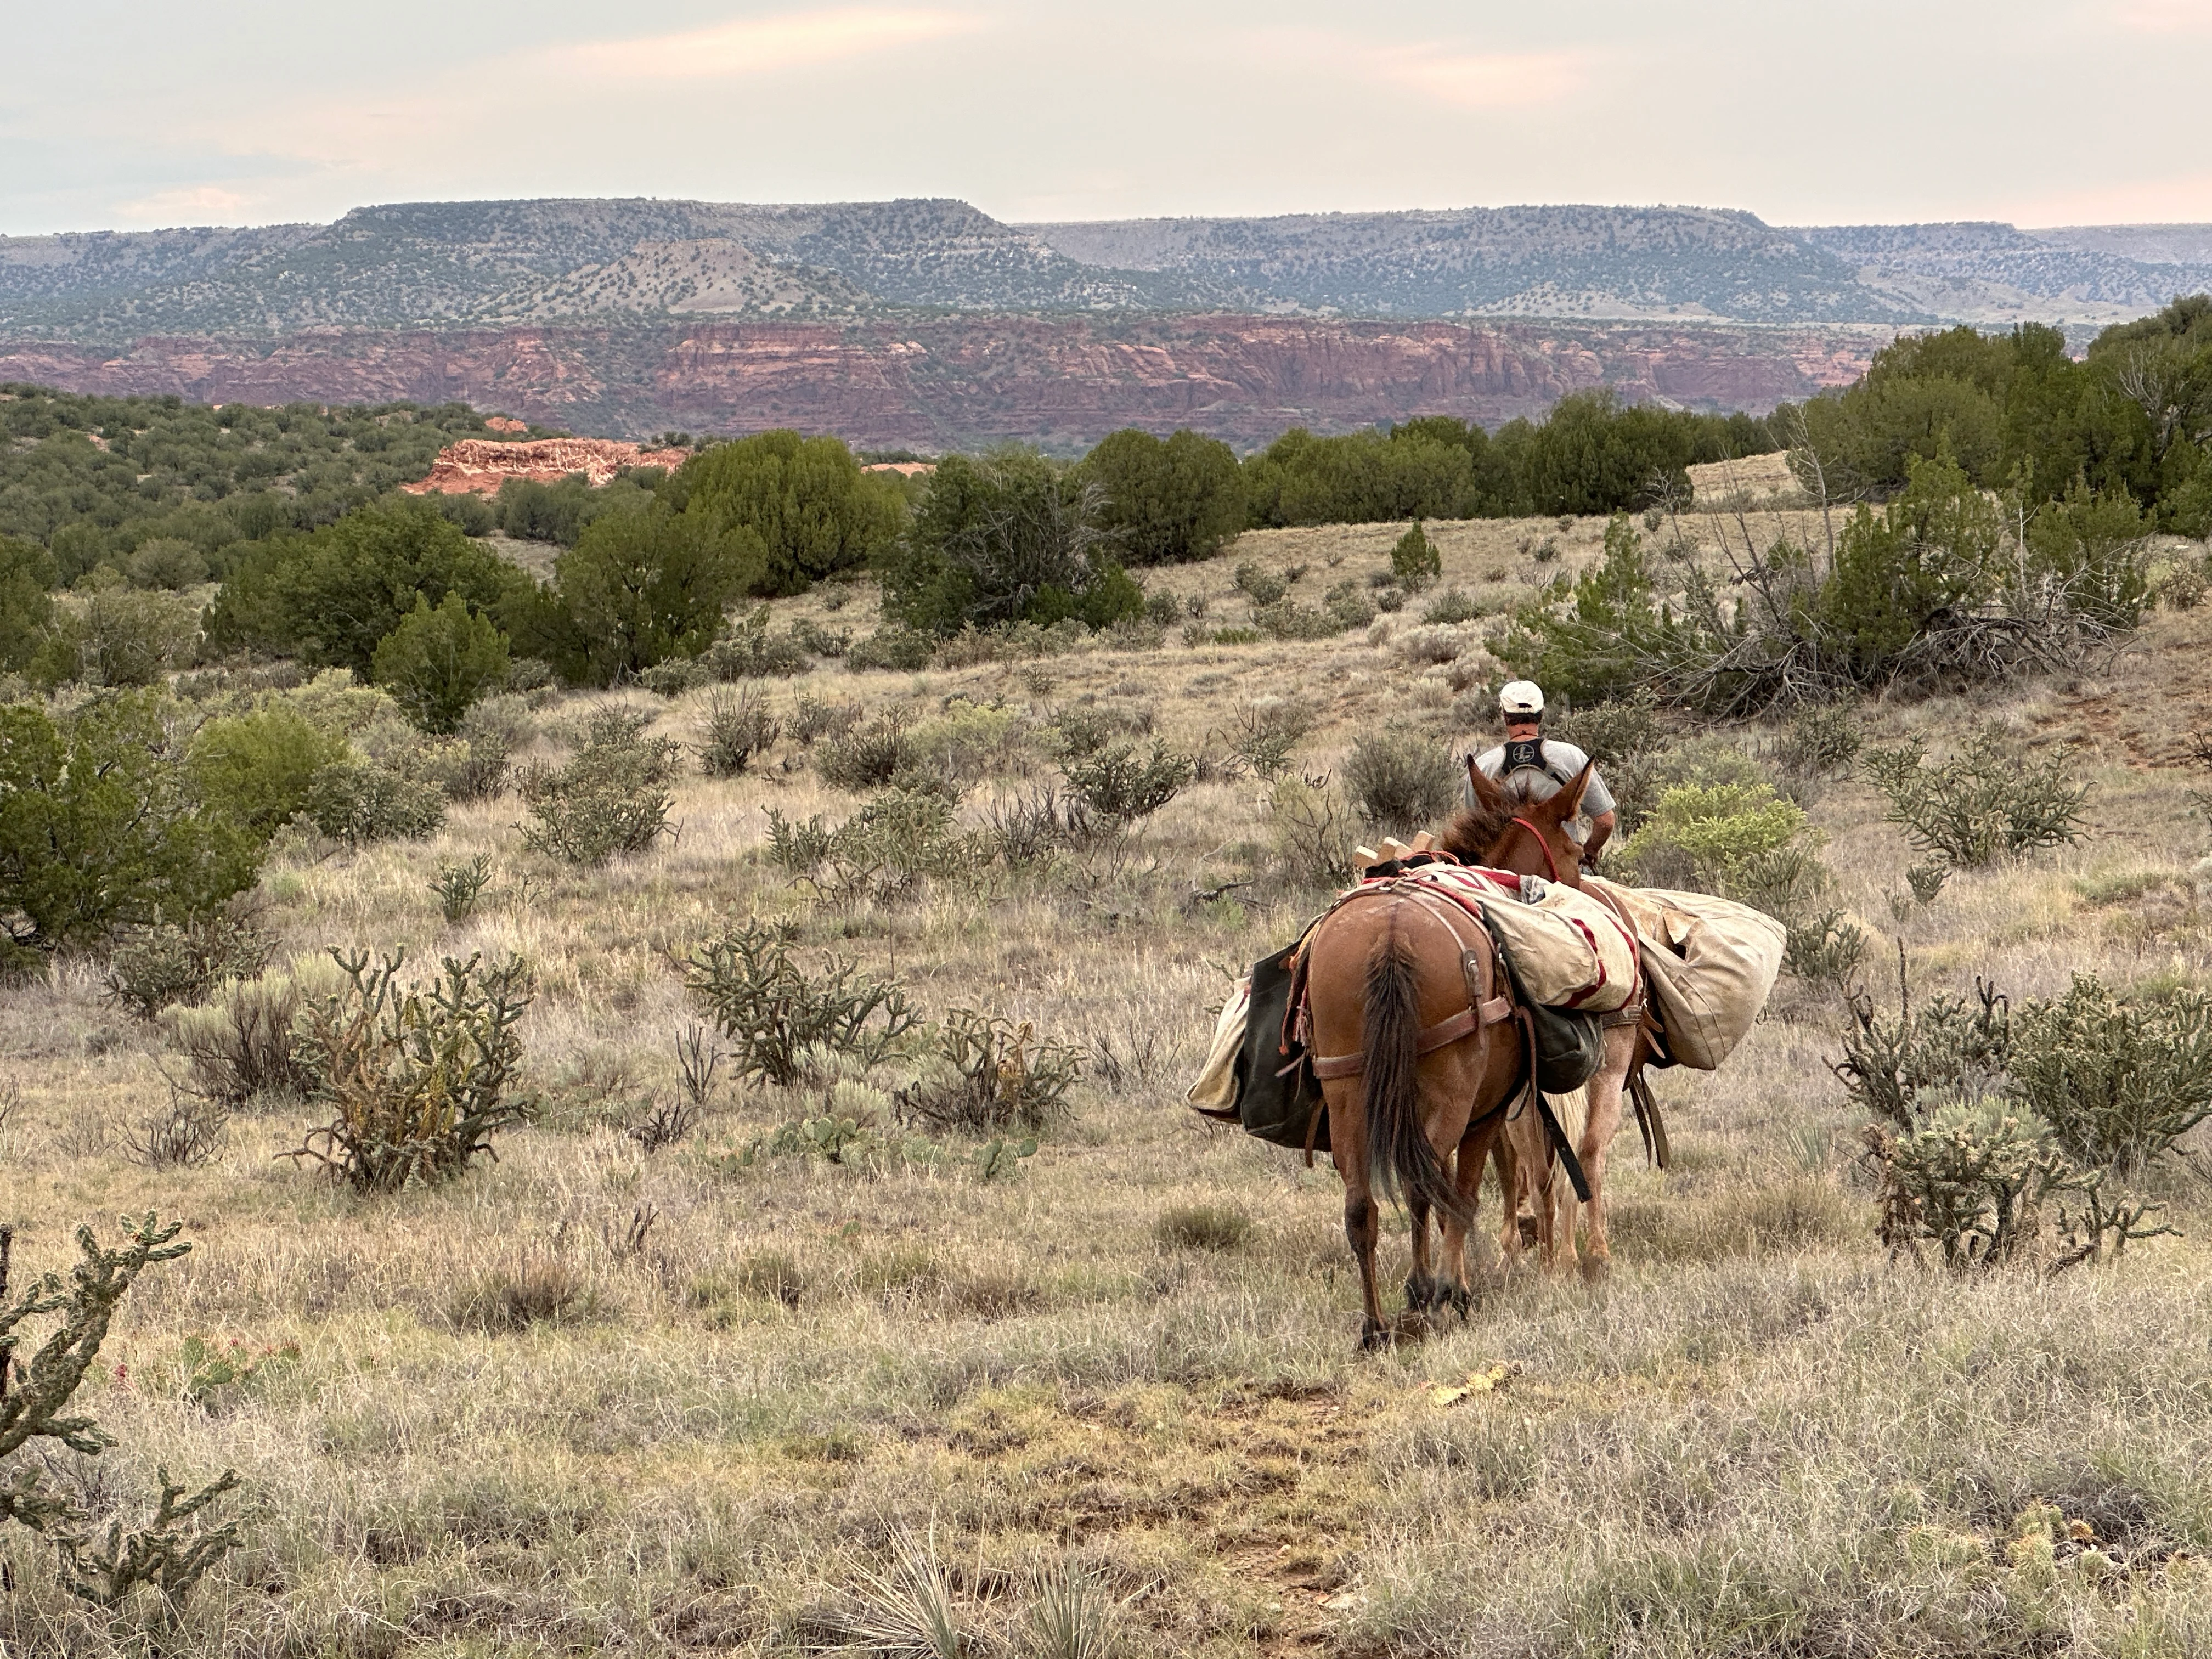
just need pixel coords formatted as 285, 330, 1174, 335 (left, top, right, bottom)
0, 0, 2212, 234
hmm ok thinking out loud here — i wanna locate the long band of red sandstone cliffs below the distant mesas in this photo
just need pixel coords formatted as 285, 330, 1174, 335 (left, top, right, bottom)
0, 317, 1889, 449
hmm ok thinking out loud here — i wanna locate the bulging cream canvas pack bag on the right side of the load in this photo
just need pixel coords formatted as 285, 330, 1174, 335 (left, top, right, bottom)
1584, 876, 1790, 1070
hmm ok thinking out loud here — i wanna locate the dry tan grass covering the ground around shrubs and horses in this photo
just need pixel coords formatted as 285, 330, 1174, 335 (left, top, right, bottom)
13, 522, 2212, 1657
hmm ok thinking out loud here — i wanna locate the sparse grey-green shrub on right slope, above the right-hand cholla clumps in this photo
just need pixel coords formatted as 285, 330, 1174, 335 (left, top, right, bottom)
1860, 728, 2088, 870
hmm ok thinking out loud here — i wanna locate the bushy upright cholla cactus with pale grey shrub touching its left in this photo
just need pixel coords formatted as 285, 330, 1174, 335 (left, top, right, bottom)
290, 951, 535, 1192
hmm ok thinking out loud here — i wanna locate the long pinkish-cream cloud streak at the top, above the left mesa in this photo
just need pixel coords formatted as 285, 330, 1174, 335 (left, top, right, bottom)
538, 7, 978, 82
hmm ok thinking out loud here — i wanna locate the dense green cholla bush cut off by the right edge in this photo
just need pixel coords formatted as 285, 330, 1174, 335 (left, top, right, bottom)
2008, 973, 2212, 1177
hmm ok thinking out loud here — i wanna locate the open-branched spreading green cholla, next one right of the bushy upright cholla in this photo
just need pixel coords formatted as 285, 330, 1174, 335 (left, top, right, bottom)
684, 920, 918, 1088
